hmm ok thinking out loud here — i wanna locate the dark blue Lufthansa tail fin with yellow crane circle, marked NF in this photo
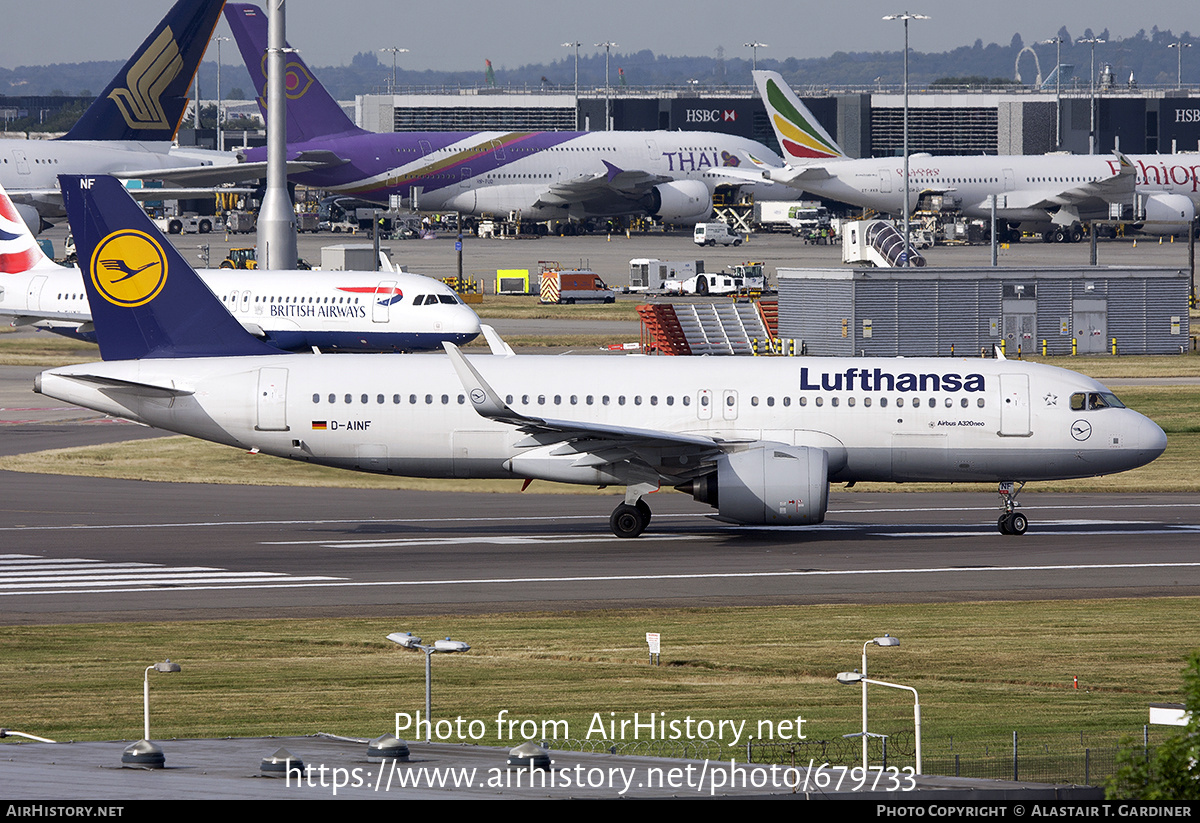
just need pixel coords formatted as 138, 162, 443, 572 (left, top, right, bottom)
59, 174, 281, 360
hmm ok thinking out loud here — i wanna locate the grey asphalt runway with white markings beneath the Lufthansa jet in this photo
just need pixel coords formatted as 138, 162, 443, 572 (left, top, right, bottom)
0, 465, 1200, 624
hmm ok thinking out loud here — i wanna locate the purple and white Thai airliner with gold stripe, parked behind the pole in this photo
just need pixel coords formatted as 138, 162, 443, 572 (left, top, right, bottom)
226, 4, 799, 223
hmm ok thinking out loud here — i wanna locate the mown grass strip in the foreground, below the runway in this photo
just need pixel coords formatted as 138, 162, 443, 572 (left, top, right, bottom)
0, 599, 1200, 757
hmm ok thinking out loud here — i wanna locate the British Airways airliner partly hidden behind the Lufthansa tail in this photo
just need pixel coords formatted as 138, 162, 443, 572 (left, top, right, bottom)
0, 183, 480, 352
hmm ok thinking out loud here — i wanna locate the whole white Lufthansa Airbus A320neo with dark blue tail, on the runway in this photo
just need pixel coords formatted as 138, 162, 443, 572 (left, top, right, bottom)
35, 175, 1166, 537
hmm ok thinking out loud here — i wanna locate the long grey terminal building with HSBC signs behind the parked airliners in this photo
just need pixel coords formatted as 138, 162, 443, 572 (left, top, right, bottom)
355, 86, 1200, 157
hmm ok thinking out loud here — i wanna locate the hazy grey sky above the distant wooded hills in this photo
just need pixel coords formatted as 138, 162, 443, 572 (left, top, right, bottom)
0, 0, 1200, 71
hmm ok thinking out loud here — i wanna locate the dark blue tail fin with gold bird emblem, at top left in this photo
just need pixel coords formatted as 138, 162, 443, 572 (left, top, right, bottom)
64, 0, 224, 142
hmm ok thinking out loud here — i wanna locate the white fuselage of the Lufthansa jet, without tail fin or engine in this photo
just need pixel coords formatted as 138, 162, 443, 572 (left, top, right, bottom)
37, 354, 1166, 485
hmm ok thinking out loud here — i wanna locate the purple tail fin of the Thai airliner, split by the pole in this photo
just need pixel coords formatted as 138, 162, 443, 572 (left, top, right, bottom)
226, 2, 364, 143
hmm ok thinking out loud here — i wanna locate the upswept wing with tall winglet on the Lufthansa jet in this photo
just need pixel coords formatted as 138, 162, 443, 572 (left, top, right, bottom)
443, 343, 749, 481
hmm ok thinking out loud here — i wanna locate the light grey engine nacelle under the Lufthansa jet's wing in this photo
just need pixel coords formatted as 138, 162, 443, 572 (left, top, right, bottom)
678, 445, 829, 525
